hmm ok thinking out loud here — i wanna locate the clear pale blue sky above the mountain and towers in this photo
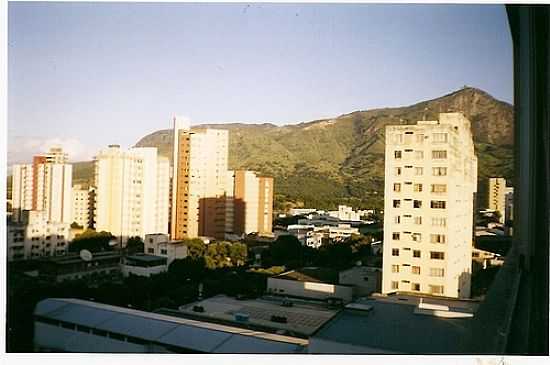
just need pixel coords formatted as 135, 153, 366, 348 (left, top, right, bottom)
8, 2, 513, 163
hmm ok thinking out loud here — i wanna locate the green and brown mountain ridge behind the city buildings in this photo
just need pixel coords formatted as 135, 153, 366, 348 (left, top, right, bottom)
66, 87, 514, 209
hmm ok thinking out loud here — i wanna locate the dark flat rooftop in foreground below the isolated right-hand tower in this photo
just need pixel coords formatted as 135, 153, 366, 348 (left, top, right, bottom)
312, 295, 478, 354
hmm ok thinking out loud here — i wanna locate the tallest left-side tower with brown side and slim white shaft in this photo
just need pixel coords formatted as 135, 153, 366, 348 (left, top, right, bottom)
174, 118, 229, 240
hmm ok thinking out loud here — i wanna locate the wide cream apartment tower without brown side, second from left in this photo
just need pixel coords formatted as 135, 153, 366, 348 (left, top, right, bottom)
95, 145, 169, 242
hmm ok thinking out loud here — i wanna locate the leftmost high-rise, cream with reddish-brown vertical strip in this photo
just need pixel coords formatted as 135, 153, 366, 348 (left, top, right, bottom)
12, 147, 73, 223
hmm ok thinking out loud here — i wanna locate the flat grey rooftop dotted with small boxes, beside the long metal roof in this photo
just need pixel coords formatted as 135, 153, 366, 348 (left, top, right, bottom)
180, 295, 338, 336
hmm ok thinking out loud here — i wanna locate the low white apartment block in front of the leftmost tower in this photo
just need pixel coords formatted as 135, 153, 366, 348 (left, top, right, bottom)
7, 210, 71, 261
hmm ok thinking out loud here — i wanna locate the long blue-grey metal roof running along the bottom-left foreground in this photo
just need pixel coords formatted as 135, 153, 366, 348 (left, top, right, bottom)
34, 299, 307, 353
